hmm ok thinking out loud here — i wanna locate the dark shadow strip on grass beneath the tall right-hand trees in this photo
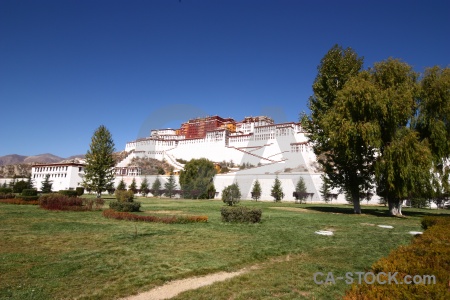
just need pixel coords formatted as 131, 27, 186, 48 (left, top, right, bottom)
304, 205, 450, 218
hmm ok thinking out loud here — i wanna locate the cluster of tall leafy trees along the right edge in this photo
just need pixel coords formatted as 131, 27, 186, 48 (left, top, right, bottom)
301, 45, 450, 215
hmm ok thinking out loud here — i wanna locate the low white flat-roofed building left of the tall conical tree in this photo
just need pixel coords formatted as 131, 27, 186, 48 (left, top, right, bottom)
31, 163, 86, 191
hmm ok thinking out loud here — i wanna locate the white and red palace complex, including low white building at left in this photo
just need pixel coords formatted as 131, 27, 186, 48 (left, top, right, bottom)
32, 116, 358, 203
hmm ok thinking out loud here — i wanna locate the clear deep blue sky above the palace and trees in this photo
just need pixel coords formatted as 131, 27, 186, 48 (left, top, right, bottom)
0, 0, 450, 157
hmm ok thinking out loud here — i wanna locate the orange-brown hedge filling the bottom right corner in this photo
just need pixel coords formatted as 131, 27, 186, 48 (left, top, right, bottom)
344, 217, 450, 300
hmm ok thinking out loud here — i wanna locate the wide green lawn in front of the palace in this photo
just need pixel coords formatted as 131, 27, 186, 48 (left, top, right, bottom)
0, 198, 449, 300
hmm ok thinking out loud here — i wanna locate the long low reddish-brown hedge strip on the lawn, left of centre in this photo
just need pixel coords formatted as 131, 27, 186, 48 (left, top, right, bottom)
103, 209, 208, 224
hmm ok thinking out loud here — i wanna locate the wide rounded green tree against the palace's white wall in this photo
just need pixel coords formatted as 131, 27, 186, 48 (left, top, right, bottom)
179, 158, 216, 199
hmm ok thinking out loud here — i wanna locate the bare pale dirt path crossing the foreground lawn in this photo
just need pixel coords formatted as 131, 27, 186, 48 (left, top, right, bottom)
122, 267, 251, 300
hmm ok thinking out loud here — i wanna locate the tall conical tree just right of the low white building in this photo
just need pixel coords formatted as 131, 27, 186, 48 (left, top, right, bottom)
84, 125, 115, 198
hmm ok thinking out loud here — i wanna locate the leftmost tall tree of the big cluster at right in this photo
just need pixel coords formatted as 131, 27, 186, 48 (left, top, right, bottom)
302, 45, 366, 213
